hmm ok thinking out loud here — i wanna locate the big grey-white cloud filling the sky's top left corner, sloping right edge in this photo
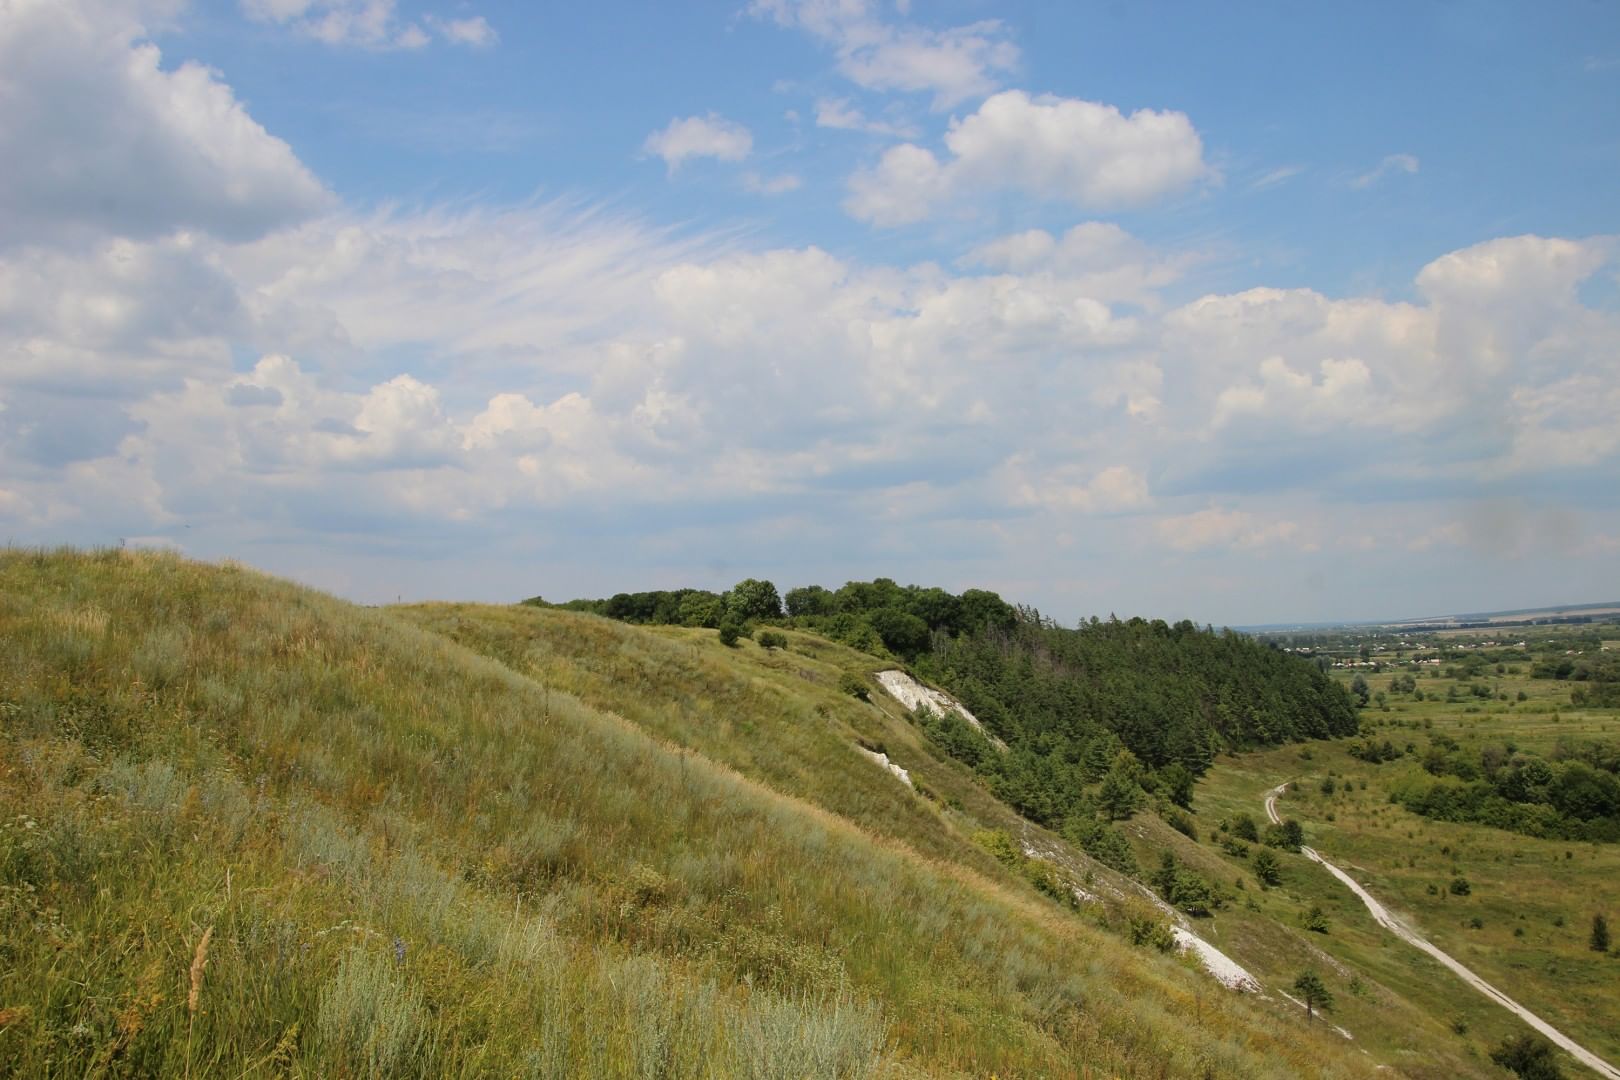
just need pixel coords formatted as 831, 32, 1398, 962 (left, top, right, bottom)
0, 0, 329, 246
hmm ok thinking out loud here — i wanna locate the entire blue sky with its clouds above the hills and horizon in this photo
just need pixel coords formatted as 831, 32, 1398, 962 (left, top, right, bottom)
0, 0, 1620, 623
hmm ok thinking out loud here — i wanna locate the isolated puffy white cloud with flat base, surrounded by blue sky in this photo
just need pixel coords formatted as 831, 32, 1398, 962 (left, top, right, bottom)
844, 91, 1212, 225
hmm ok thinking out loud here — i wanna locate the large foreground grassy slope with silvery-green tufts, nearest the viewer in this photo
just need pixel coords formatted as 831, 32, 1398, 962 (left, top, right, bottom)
0, 551, 1372, 1078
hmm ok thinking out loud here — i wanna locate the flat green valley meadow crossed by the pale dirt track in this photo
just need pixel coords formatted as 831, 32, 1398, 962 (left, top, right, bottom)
1194, 674, 1620, 1077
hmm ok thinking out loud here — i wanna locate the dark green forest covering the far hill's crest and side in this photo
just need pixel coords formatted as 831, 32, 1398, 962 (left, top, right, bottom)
525, 578, 1358, 850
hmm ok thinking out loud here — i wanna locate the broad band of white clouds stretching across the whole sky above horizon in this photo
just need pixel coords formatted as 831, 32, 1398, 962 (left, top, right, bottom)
0, 207, 1620, 563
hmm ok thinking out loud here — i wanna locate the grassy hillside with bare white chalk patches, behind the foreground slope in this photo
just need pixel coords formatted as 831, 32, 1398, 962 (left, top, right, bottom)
414, 604, 1529, 1077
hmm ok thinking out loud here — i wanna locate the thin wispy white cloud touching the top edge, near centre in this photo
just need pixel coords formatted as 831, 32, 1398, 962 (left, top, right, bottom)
748, 0, 1019, 108
